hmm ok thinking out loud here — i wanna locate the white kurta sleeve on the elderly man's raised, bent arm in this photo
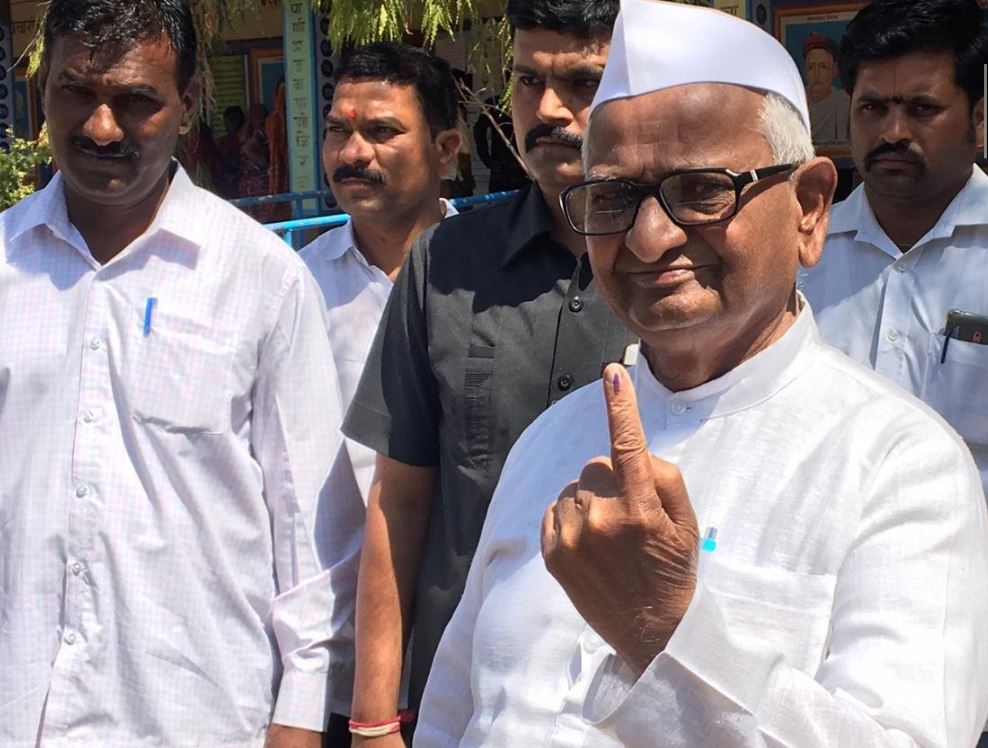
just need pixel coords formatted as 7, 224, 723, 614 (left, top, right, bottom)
586, 428, 988, 748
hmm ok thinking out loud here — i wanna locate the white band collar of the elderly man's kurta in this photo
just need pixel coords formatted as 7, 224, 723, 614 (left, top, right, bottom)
632, 295, 822, 421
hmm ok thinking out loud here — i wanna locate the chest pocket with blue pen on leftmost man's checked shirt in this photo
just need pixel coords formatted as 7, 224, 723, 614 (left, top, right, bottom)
117, 309, 236, 434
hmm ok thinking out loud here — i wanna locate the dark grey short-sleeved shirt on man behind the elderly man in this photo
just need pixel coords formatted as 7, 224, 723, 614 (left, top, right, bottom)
343, 188, 634, 706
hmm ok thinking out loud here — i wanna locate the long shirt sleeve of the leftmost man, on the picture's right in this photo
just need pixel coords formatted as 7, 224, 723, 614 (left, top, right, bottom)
251, 263, 342, 731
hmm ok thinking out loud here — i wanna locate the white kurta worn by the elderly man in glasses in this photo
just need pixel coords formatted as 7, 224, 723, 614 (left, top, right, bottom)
415, 307, 988, 748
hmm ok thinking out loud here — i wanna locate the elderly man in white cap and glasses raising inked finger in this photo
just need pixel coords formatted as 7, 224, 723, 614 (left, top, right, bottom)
416, 0, 988, 748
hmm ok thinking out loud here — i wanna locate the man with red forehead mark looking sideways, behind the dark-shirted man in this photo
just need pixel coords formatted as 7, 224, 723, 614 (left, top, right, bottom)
300, 43, 460, 746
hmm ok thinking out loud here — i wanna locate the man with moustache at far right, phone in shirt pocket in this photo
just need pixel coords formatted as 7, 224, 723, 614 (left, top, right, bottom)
801, 0, 988, 502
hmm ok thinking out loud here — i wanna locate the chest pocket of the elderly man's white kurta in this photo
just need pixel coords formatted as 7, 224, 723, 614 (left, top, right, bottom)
701, 553, 837, 675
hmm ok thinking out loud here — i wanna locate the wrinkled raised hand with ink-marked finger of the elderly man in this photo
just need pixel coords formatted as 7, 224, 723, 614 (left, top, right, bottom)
542, 364, 699, 674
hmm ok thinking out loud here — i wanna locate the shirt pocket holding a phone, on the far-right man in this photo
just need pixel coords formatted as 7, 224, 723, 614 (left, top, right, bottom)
922, 333, 988, 446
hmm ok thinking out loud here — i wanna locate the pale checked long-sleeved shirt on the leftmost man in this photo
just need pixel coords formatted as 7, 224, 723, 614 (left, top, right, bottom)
0, 167, 341, 748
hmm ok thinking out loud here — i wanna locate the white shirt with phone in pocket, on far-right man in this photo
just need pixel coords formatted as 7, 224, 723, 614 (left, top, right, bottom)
800, 168, 988, 487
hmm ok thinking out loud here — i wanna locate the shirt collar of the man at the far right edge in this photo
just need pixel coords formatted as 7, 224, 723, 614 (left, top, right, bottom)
827, 166, 988, 257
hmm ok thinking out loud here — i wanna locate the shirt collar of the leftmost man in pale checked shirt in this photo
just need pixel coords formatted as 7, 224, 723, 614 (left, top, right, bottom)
7, 161, 206, 254
